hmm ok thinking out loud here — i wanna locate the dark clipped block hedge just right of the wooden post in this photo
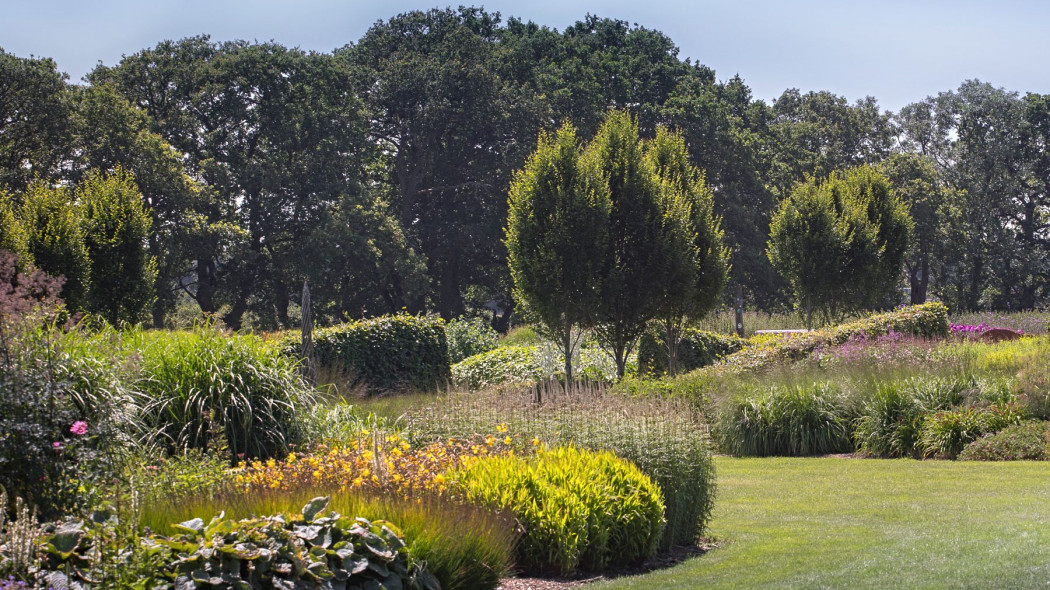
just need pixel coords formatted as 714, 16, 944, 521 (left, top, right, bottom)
306, 314, 449, 393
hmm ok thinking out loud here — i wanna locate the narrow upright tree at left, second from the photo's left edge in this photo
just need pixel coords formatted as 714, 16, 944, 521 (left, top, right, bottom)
17, 181, 91, 312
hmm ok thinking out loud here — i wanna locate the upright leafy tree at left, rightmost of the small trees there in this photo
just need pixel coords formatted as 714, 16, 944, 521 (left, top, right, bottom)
77, 168, 156, 325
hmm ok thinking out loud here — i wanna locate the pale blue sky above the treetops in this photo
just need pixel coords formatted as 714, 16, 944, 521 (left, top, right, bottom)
0, 0, 1050, 111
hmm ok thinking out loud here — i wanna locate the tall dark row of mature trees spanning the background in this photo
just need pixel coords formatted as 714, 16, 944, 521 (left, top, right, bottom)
0, 7, 1050, 328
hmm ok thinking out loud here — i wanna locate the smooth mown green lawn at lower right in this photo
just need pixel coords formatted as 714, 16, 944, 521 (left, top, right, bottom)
595, 458, 1050, 589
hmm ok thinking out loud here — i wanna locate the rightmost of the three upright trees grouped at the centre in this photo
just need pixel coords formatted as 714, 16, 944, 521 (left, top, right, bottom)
646, 127, 729, 375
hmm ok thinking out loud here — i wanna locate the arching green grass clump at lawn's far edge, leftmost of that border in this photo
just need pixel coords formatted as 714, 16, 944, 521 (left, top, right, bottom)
716, 383, 852, 457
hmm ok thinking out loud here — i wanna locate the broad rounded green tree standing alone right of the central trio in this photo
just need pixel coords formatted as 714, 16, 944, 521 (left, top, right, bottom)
768, 166, 912, 326
